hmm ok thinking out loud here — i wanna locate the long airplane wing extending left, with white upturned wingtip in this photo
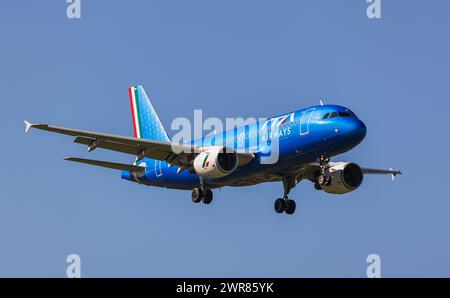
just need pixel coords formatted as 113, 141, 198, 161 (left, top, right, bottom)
25, 121, 255, 169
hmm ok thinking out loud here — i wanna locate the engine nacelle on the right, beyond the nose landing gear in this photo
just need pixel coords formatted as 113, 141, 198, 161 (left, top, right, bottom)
321, 162, 364, 194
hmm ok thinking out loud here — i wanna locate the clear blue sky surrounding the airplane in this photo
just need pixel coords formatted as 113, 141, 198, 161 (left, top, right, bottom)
0, 0, 450, 277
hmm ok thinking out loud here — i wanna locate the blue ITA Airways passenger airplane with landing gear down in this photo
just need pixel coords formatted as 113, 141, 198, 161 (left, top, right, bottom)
25, 86, 401, 214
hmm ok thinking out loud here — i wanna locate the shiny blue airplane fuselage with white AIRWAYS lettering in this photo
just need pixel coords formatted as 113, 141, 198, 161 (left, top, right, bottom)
122, 105, 366, 189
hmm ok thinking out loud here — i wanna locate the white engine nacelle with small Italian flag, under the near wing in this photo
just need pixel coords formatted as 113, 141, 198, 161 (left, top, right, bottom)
194, 146, 238, 178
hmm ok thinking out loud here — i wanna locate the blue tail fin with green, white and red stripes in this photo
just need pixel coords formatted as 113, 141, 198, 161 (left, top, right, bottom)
128, 86, 170, 141
